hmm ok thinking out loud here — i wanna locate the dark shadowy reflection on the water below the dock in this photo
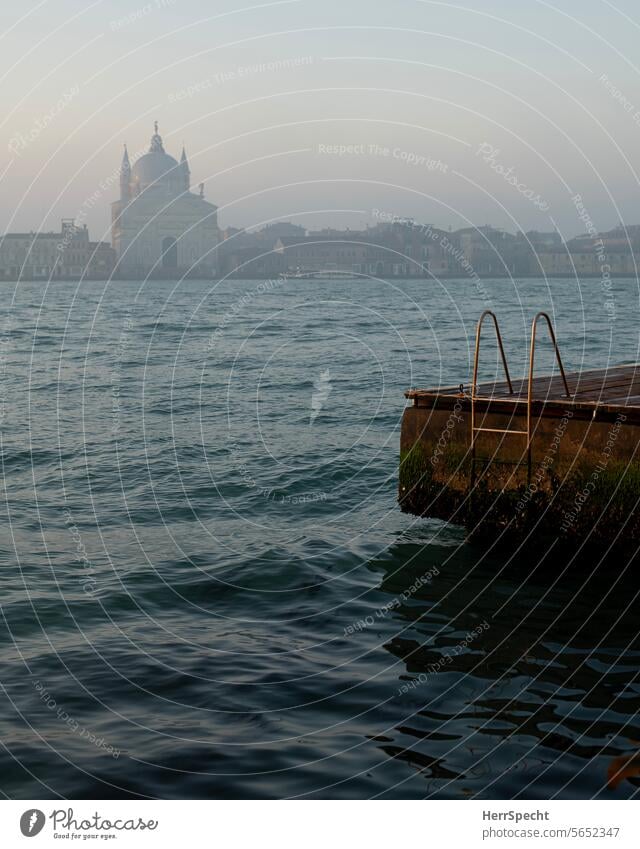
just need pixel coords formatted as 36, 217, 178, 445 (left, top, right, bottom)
372, 536, 640, 798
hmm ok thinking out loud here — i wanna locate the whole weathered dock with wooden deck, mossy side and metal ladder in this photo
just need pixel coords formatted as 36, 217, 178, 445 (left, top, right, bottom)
399, 313, 640, 553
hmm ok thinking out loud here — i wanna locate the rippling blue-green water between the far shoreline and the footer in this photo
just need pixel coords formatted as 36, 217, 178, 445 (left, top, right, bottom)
0, 280, 640, 798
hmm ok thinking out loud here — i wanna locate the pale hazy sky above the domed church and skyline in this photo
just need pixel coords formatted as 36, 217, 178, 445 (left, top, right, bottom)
0, 0, 640, 239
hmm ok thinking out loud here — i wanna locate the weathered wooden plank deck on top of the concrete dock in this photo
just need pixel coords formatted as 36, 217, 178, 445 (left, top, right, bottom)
405, 363, 640, 422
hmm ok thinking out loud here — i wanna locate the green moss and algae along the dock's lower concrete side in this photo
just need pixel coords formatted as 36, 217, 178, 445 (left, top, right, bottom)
399, 442, 640, 550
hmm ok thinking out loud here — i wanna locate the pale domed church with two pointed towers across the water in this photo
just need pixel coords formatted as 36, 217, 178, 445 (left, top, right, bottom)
111, 121, 219, 279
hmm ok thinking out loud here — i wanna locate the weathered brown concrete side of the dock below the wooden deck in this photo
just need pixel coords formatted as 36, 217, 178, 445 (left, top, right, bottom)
399, 396, 640, 553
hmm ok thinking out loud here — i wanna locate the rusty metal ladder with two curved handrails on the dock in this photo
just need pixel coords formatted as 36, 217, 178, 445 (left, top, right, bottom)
471, 310, 571, 482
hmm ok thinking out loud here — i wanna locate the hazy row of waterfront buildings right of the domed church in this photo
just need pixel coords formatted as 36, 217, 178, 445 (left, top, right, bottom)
219, 219, 640, 279
